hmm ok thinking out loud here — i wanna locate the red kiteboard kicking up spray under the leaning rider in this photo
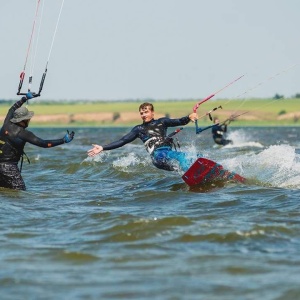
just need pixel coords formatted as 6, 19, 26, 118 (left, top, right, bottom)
182, 157, 246, 186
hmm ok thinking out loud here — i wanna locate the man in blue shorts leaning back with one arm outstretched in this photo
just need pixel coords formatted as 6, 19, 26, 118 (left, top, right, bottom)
88, 103, 198, 172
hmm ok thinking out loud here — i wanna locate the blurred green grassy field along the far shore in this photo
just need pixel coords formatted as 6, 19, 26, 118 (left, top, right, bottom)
0, 98, 300, 126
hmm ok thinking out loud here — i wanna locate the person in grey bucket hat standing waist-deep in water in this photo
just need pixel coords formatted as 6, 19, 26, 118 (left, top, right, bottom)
0, 93, 74, 190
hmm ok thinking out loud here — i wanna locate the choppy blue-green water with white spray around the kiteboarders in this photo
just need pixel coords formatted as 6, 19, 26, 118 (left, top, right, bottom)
0, 126, 300, 300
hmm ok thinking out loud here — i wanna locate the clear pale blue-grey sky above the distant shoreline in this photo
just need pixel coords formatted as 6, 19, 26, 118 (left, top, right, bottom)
0, 0, 300, 100
